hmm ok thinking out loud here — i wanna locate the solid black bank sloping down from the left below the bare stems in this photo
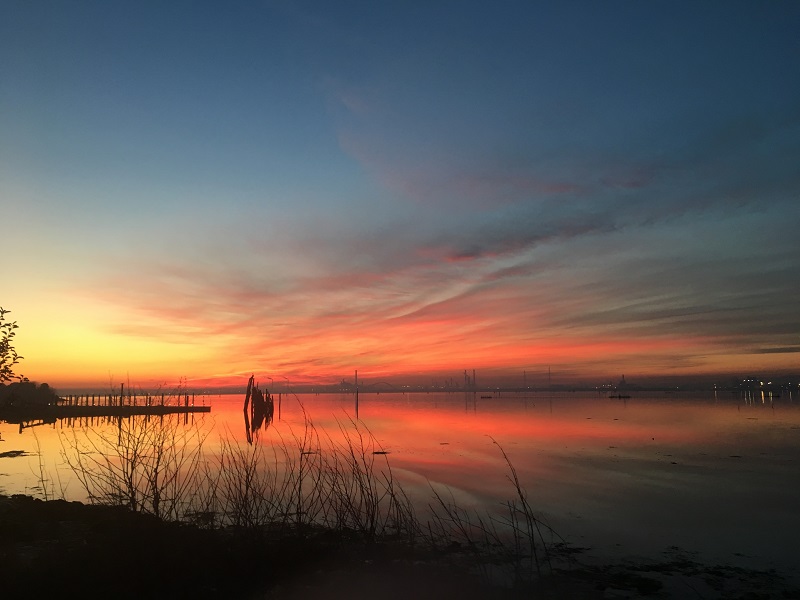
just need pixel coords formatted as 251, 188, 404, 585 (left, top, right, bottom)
0, 496, 520, 598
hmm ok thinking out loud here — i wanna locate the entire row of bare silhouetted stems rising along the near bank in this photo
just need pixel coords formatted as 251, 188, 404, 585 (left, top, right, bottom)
59, 398, 557, 582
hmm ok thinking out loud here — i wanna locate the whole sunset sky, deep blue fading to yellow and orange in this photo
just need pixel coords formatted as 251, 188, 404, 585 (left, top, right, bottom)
0, 0, 800, 389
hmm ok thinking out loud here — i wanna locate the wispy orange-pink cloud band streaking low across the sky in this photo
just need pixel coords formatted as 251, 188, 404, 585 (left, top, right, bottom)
76, 185, 800, 378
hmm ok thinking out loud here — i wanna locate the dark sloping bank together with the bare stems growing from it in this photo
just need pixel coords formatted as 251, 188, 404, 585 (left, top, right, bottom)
0, 406, 576, 598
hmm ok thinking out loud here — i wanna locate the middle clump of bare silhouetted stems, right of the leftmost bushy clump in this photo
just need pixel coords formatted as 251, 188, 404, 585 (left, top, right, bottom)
209, 413, 417, 541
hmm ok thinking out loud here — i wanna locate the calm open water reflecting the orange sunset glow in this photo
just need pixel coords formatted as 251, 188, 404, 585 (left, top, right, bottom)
0, 393, 800, 571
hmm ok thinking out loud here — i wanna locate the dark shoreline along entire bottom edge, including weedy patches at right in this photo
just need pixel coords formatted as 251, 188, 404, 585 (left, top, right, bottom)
0, 494, 800, 600
